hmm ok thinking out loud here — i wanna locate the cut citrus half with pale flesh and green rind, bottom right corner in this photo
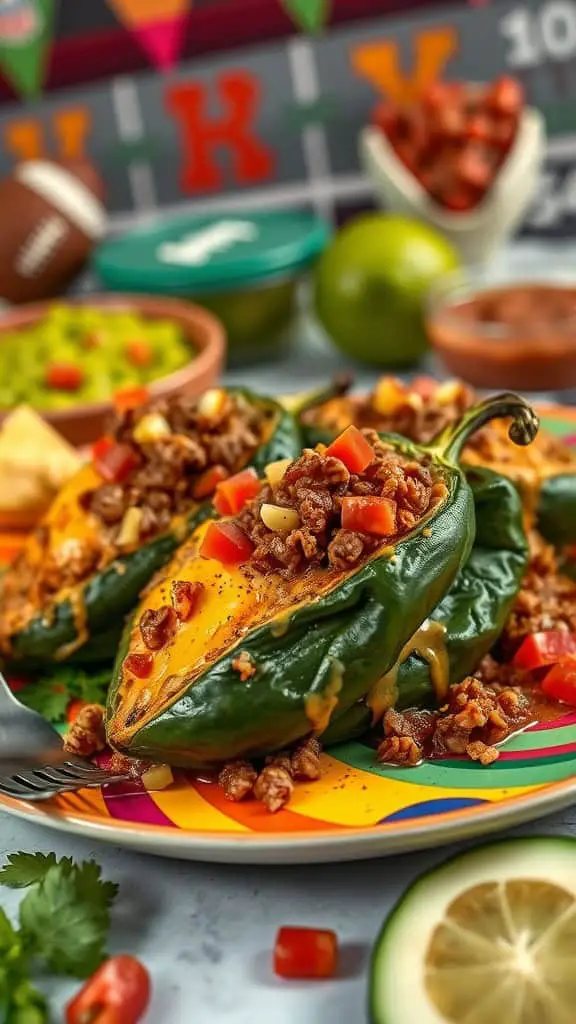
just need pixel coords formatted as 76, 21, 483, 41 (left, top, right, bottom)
370, 838, 576, 1024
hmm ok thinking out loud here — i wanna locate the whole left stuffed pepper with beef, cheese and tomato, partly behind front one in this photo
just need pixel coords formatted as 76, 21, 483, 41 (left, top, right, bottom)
0, 388, 301, 668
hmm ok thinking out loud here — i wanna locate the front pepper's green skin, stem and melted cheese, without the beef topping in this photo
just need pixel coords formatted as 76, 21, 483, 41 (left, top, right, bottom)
107, 394, 538, 768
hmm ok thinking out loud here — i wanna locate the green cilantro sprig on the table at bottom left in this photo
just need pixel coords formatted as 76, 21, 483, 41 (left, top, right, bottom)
0, 852, 118, 1024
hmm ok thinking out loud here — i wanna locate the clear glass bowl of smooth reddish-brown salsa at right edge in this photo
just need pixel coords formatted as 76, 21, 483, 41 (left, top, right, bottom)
426, 268, 576, 391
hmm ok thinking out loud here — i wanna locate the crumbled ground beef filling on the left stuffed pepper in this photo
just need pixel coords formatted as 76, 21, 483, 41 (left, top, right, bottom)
82, 391, 262, 545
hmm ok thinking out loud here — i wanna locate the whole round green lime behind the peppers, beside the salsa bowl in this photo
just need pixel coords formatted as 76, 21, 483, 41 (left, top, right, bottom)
315, 213, 459, 367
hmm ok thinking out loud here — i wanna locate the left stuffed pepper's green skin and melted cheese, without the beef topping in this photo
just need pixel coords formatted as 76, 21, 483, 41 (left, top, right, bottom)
0, 389, 301, 669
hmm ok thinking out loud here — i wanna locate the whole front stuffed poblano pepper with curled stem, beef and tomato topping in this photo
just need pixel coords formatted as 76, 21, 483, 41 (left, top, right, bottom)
107, 394, 538, 768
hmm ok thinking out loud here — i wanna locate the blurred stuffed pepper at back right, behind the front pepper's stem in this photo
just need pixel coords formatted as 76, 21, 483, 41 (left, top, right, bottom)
298, 377, 576, 547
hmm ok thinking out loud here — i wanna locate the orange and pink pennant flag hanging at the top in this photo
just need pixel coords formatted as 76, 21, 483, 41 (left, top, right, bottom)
105, 0, 192, 71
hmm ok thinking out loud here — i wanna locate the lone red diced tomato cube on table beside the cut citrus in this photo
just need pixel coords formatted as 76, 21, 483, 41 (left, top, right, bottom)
274, 928, 338, 978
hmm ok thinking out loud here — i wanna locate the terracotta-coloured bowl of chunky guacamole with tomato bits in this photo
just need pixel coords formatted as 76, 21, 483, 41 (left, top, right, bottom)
0, 295, 225, 444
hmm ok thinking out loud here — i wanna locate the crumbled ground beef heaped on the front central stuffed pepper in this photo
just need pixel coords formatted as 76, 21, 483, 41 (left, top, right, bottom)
236, 430, 447, 573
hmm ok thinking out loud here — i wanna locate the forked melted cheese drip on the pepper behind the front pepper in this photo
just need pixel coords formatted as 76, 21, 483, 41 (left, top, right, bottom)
366, 618, 450, 723
